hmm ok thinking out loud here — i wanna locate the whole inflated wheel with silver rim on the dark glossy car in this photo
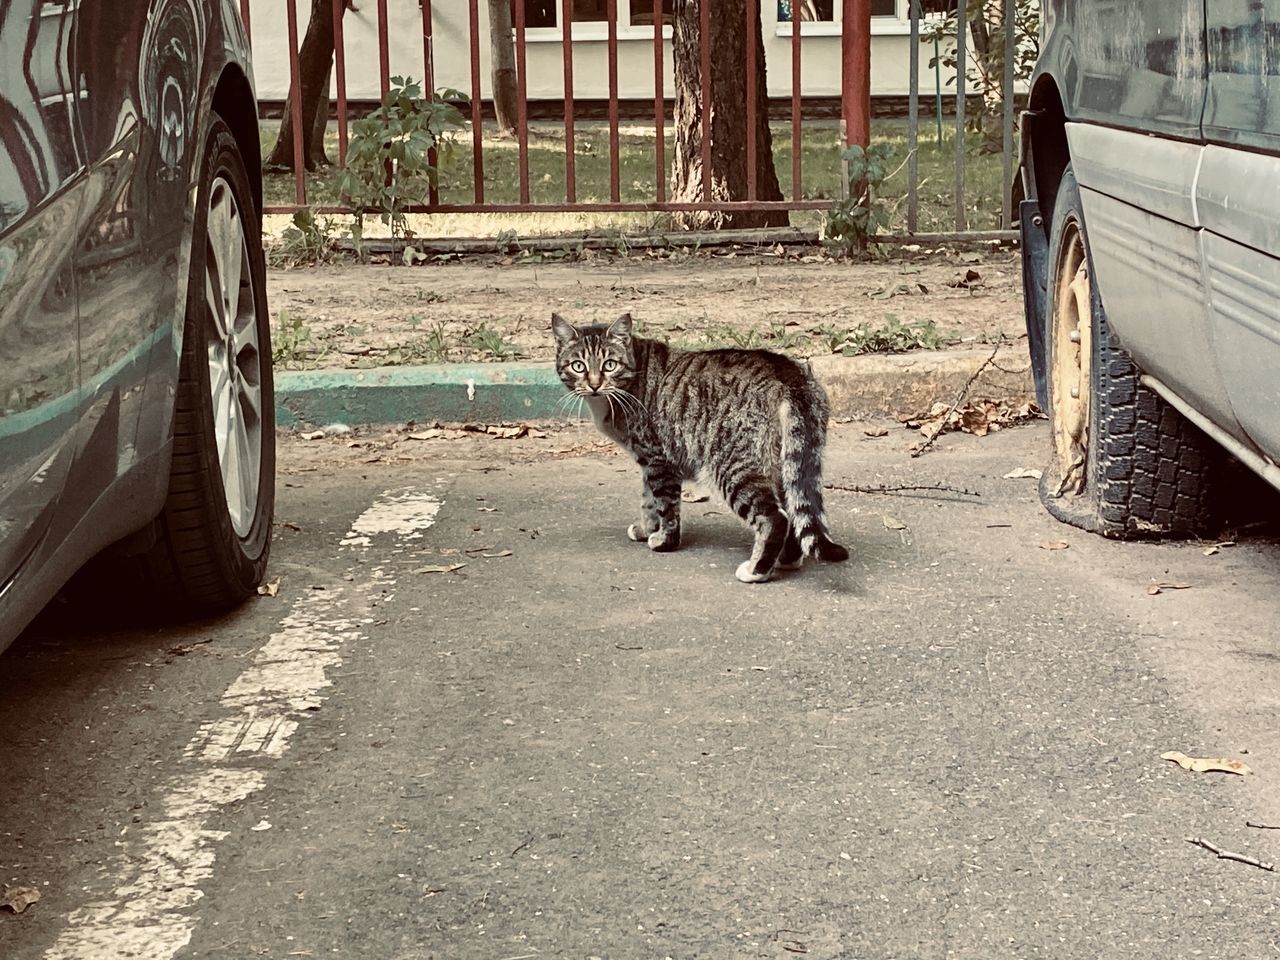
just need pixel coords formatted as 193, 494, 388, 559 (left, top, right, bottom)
142, 114, 275, 613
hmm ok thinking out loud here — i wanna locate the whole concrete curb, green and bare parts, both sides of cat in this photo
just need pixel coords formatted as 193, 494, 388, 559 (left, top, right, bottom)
275, 344, 1036, 428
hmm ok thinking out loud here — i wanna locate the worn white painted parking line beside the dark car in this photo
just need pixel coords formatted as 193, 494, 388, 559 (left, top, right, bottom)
45, 490, 443, 960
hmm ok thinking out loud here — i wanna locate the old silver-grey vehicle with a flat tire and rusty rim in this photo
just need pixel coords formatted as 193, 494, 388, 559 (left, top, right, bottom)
1020, 0, 1280, 536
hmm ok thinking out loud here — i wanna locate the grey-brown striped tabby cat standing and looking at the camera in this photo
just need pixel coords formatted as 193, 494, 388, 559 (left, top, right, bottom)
552, 314, 849, 584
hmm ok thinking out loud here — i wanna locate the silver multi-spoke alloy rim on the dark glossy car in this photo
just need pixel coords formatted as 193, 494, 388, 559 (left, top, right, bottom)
205, 177, 262, 538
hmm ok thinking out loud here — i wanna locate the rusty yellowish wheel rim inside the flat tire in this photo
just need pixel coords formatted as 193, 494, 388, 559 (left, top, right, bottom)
1050, 223, 1093, 497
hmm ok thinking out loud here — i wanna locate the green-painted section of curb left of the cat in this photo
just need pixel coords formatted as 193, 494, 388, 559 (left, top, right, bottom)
275, 364, 564, 426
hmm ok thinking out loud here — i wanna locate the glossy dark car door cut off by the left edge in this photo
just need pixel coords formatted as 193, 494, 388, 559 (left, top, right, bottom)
0, 0, 83, 588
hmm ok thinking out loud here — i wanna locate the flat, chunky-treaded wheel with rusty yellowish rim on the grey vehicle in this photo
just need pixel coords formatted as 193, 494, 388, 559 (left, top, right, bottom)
1041, 166, 1225, 539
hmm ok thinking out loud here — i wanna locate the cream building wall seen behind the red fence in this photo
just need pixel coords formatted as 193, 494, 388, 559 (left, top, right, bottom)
250, 0, 954, 100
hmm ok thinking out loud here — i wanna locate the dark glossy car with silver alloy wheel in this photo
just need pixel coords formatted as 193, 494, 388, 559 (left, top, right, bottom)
0, 0, 275, 649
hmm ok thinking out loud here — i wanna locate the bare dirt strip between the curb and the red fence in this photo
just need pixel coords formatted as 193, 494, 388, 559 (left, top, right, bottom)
268, 247, 1024, 369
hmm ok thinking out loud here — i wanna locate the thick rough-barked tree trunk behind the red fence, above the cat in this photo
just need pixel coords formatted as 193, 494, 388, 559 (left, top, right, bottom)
672, 0, 790, 229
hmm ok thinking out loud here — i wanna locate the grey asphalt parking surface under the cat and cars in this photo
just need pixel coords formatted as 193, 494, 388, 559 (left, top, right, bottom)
0, 425, 1280, 960
